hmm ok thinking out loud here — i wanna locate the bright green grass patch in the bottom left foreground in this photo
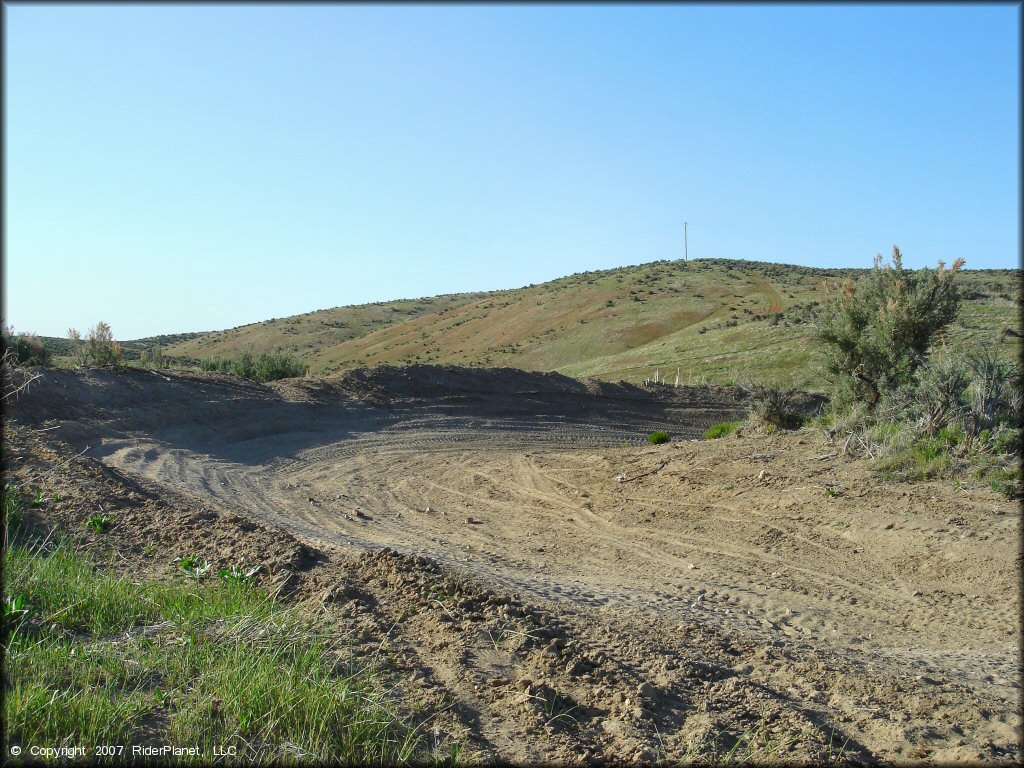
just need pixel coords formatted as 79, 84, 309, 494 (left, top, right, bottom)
4, 493, 416, 764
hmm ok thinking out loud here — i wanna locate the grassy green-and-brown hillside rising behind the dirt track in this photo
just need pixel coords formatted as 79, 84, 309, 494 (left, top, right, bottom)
148, 259, 1020, 387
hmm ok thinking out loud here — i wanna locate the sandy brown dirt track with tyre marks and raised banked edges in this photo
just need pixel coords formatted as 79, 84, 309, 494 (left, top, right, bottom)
5, 367, 1021, 763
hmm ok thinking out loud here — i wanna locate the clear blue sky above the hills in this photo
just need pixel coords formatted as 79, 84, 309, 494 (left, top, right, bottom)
4, 3, 1021, 339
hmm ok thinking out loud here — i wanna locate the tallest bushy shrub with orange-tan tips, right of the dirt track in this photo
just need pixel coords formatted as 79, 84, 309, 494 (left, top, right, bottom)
818, 246, 964, 409
